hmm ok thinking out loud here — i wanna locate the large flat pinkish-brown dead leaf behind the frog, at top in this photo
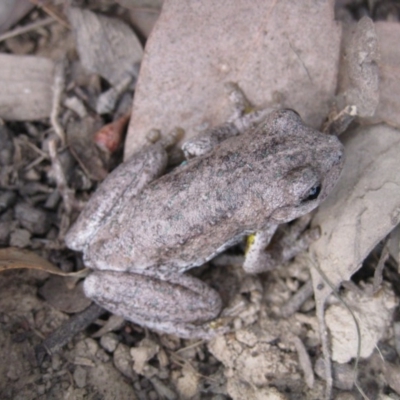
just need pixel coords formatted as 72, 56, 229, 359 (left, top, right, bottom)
125, 0, 341, 158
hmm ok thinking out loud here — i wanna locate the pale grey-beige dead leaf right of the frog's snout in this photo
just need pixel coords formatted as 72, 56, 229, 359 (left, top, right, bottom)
310, 124, 400, 303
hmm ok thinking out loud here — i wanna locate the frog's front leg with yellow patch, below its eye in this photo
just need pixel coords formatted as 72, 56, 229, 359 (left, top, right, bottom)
243, 214, 320, 274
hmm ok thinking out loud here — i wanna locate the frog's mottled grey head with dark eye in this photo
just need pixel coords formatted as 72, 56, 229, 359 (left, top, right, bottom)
270, 110, 344, 223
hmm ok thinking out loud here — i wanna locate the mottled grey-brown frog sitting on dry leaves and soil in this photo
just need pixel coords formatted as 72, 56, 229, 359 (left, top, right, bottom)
65, 86, 344, 340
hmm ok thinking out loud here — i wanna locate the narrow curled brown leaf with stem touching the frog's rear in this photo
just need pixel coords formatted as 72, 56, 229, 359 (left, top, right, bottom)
0, 247, 88, 277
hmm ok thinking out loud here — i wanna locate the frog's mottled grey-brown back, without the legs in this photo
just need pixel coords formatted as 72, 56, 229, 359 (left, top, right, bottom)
89, 111, 342, 270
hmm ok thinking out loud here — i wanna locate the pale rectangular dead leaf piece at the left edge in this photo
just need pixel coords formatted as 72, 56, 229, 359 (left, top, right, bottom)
0, 54, 54, 121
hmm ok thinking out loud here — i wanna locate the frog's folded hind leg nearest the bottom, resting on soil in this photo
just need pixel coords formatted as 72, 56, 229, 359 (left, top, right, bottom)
84, 271, 227, 339
